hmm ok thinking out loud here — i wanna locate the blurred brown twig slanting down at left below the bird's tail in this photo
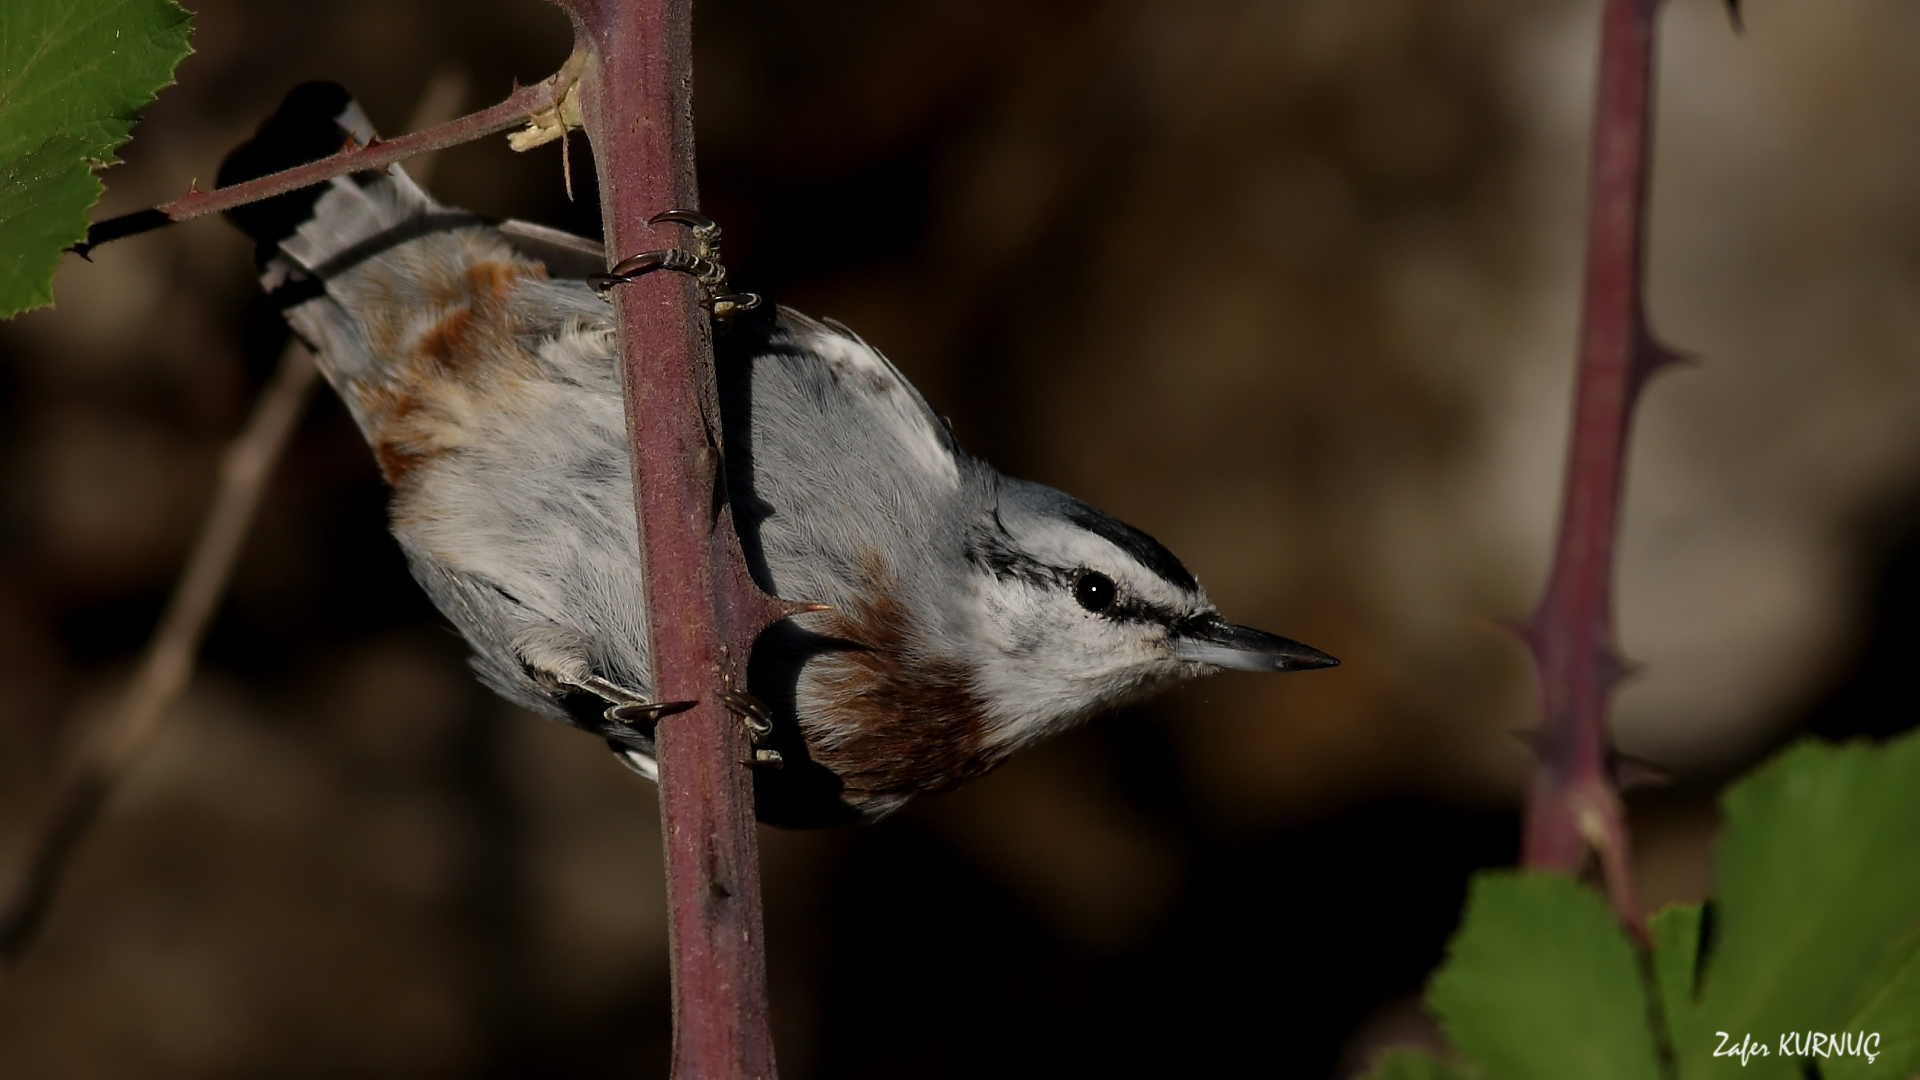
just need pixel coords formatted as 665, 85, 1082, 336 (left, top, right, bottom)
0, 344, 315, 969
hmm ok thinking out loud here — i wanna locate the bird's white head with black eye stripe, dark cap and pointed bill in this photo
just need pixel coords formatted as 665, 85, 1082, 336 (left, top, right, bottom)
966, 479, 1340, 746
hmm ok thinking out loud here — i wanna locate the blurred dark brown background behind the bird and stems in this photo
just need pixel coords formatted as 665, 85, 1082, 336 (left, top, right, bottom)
0, 0, 1920, 1080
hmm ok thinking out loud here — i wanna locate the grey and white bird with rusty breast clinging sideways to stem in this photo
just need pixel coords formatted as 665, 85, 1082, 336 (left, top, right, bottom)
219, 83, 1338, 826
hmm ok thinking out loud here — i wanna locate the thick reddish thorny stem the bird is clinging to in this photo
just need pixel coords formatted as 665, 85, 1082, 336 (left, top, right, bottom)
559, 0, 797, 1080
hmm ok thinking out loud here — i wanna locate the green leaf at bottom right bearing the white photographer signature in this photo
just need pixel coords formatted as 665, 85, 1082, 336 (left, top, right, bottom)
1689, 734, 1920, 1080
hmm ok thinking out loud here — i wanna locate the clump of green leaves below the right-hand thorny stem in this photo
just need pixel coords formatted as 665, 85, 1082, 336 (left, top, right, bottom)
1420, 732, 1920, 1080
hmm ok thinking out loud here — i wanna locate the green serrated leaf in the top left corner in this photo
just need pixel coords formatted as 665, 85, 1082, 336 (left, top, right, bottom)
0, 0, 190, 319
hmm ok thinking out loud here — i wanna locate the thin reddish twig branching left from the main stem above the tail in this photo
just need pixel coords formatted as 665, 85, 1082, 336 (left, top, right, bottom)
73, 54, 580, 258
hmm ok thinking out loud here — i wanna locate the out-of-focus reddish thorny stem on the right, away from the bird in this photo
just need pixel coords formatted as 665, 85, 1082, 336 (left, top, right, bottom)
1523, 0, 1674, 934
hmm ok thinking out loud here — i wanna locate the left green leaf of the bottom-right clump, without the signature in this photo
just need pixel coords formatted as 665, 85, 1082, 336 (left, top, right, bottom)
1427, 872, 1659, 1080
